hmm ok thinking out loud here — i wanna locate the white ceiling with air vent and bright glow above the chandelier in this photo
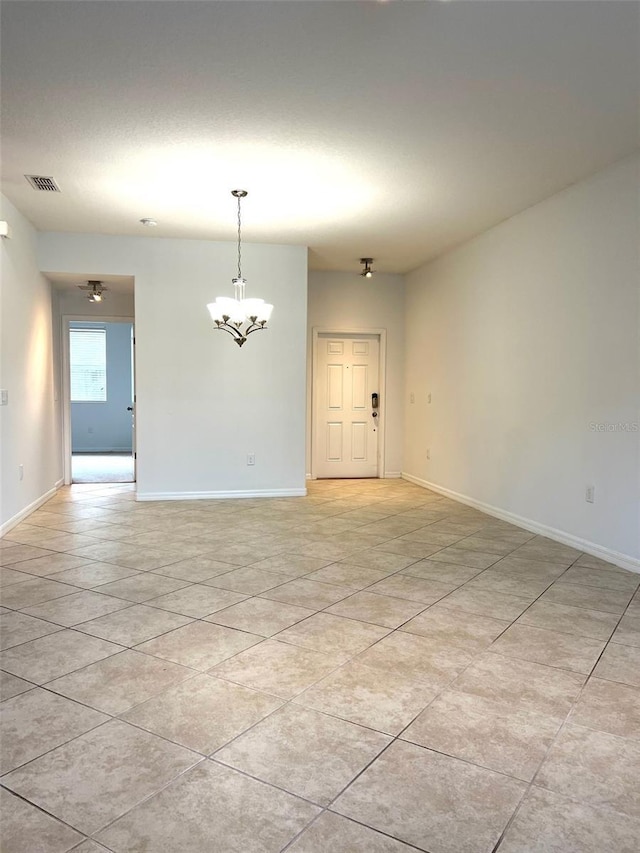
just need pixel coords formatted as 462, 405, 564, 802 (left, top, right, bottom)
2, 0, 640, 272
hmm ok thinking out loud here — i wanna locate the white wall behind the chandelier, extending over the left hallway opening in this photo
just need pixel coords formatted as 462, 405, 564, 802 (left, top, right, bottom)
39, 233, 307, 499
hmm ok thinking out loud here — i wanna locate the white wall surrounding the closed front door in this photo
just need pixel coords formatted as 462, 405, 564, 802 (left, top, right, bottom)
307, 271, 404, 477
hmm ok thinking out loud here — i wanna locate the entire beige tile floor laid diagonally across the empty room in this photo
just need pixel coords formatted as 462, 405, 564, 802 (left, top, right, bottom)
0, 480, 640, 853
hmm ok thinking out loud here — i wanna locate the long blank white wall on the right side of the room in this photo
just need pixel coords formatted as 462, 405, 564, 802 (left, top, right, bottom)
404, 158, 640, 566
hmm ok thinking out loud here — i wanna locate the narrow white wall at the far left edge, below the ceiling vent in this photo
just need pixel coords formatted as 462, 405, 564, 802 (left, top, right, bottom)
0, 197, 62, 530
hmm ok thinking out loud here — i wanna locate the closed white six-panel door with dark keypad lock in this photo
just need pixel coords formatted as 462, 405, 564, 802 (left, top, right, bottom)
313, 334, 380, 478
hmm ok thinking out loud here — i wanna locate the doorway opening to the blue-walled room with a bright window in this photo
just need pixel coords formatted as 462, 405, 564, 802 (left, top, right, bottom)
65, 318, 136, 483
